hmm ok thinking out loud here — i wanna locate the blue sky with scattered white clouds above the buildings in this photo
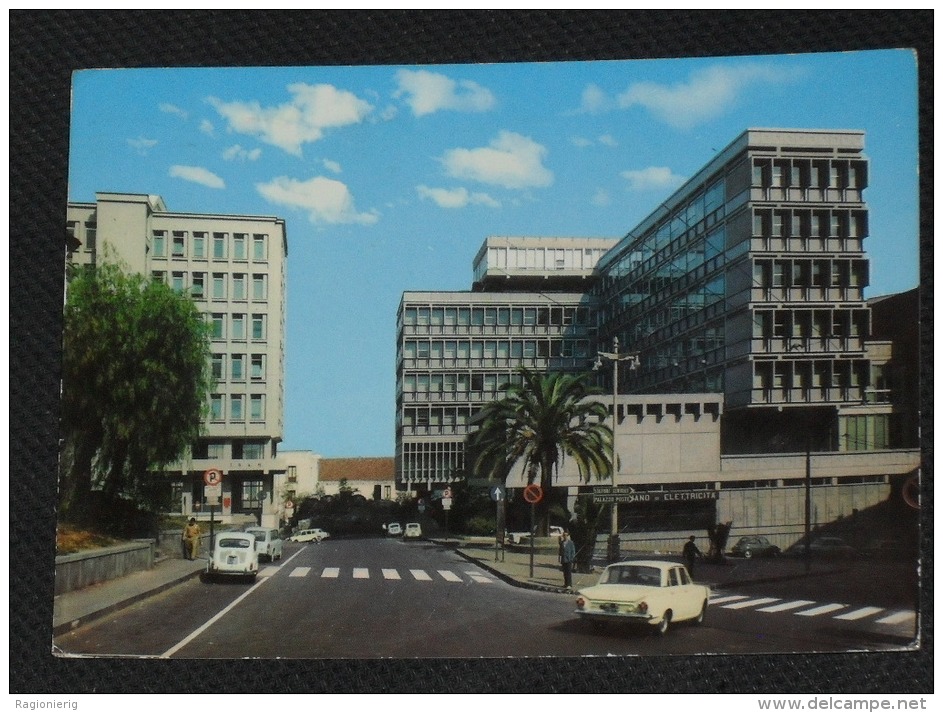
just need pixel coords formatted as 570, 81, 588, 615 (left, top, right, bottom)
69, 50, 918, 457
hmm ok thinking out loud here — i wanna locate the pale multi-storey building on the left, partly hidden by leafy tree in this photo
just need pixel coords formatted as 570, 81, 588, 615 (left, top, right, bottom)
67, 193, 288, 526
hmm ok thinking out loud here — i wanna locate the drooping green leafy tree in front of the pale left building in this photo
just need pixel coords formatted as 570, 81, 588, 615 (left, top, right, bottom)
59, 263, 210, 524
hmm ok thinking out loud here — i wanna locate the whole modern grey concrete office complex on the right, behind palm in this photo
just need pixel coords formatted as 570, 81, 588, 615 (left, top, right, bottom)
396, 129, 919, 544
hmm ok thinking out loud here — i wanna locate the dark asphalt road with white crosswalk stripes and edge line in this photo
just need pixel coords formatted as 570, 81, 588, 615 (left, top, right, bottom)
55, 538, 913, 659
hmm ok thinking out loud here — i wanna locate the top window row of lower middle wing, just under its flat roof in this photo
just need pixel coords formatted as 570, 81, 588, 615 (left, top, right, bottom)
403, 307, 589, 327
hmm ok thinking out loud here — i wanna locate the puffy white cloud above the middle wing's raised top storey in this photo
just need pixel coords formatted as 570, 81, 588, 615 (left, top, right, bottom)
442, 131, 553, 188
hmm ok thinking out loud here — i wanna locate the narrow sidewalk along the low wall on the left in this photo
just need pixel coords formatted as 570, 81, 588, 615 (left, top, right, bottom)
52, 558, 206, 636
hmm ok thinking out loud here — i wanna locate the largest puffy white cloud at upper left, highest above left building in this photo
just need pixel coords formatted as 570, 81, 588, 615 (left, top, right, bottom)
207, 83, 373, 156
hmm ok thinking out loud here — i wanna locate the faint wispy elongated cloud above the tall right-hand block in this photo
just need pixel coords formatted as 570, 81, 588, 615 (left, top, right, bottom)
619, 64, 797, 129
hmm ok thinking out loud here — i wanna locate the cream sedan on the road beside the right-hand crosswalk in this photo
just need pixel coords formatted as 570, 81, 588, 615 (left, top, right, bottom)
576, 560, 710, 634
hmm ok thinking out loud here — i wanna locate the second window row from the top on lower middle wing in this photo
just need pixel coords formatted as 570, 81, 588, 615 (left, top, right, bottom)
403, 339, 589, 361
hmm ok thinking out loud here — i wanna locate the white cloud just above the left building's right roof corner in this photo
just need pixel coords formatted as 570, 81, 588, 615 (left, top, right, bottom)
255, 176, 379, 225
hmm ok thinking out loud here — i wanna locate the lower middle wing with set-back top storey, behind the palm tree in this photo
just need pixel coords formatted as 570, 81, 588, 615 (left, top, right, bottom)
396, 237, 616, 490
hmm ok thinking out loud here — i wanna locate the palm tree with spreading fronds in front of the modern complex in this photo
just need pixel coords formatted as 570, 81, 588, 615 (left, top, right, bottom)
466, 368, 612, 534
